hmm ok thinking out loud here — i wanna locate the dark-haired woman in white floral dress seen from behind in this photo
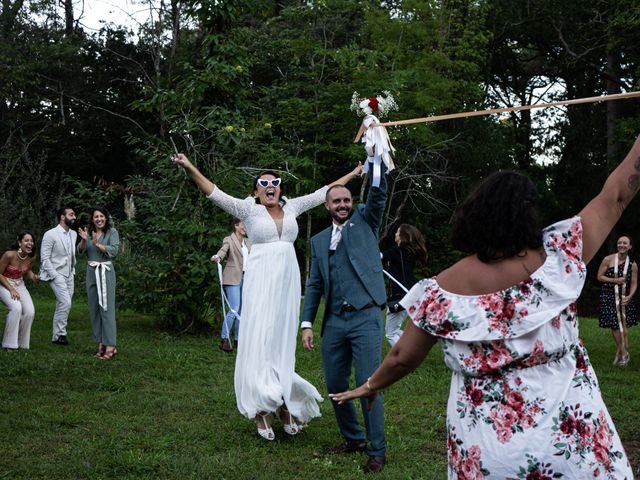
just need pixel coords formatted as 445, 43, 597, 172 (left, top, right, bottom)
330, 137, 640, 479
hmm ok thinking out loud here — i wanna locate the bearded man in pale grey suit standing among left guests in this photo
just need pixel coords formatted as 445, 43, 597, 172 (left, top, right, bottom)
40, 206, 77, 345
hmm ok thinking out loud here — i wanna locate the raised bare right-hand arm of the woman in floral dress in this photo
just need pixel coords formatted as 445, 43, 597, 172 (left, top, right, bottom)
580, 136, 640, 263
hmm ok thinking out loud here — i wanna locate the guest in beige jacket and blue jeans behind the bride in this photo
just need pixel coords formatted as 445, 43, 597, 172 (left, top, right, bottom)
211, 218, 251, 352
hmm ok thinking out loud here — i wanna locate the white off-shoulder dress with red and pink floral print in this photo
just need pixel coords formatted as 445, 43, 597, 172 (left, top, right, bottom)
401, 217, 633, 480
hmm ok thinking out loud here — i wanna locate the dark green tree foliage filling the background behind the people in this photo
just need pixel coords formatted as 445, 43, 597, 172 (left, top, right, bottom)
0, 0, 640, 330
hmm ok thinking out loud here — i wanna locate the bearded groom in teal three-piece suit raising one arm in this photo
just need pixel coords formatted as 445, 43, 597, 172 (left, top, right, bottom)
301, 169, 387, 473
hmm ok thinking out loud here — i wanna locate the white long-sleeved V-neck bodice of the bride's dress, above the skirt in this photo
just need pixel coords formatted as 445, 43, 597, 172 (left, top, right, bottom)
207, 186, 328, 245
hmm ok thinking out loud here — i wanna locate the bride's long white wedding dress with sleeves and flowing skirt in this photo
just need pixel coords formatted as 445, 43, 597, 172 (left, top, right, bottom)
207, 186, 328, 423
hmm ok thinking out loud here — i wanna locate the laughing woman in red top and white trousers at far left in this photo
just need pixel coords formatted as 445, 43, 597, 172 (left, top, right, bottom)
0, 232, 40, 350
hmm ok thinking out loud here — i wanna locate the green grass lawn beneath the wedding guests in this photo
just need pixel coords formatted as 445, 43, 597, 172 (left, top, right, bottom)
0, 287, 640, 480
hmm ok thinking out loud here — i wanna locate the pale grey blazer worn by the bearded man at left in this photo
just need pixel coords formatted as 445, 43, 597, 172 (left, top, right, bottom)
40, 225, 78, 282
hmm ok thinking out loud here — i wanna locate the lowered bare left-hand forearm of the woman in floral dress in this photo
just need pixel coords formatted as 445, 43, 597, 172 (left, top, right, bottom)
329, 321, 437, 409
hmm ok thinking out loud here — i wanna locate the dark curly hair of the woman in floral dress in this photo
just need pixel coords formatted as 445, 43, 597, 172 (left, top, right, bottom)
451, 171, 542, 262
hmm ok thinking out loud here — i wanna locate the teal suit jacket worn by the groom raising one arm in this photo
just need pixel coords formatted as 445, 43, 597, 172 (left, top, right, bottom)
302, 174, 387, 334
